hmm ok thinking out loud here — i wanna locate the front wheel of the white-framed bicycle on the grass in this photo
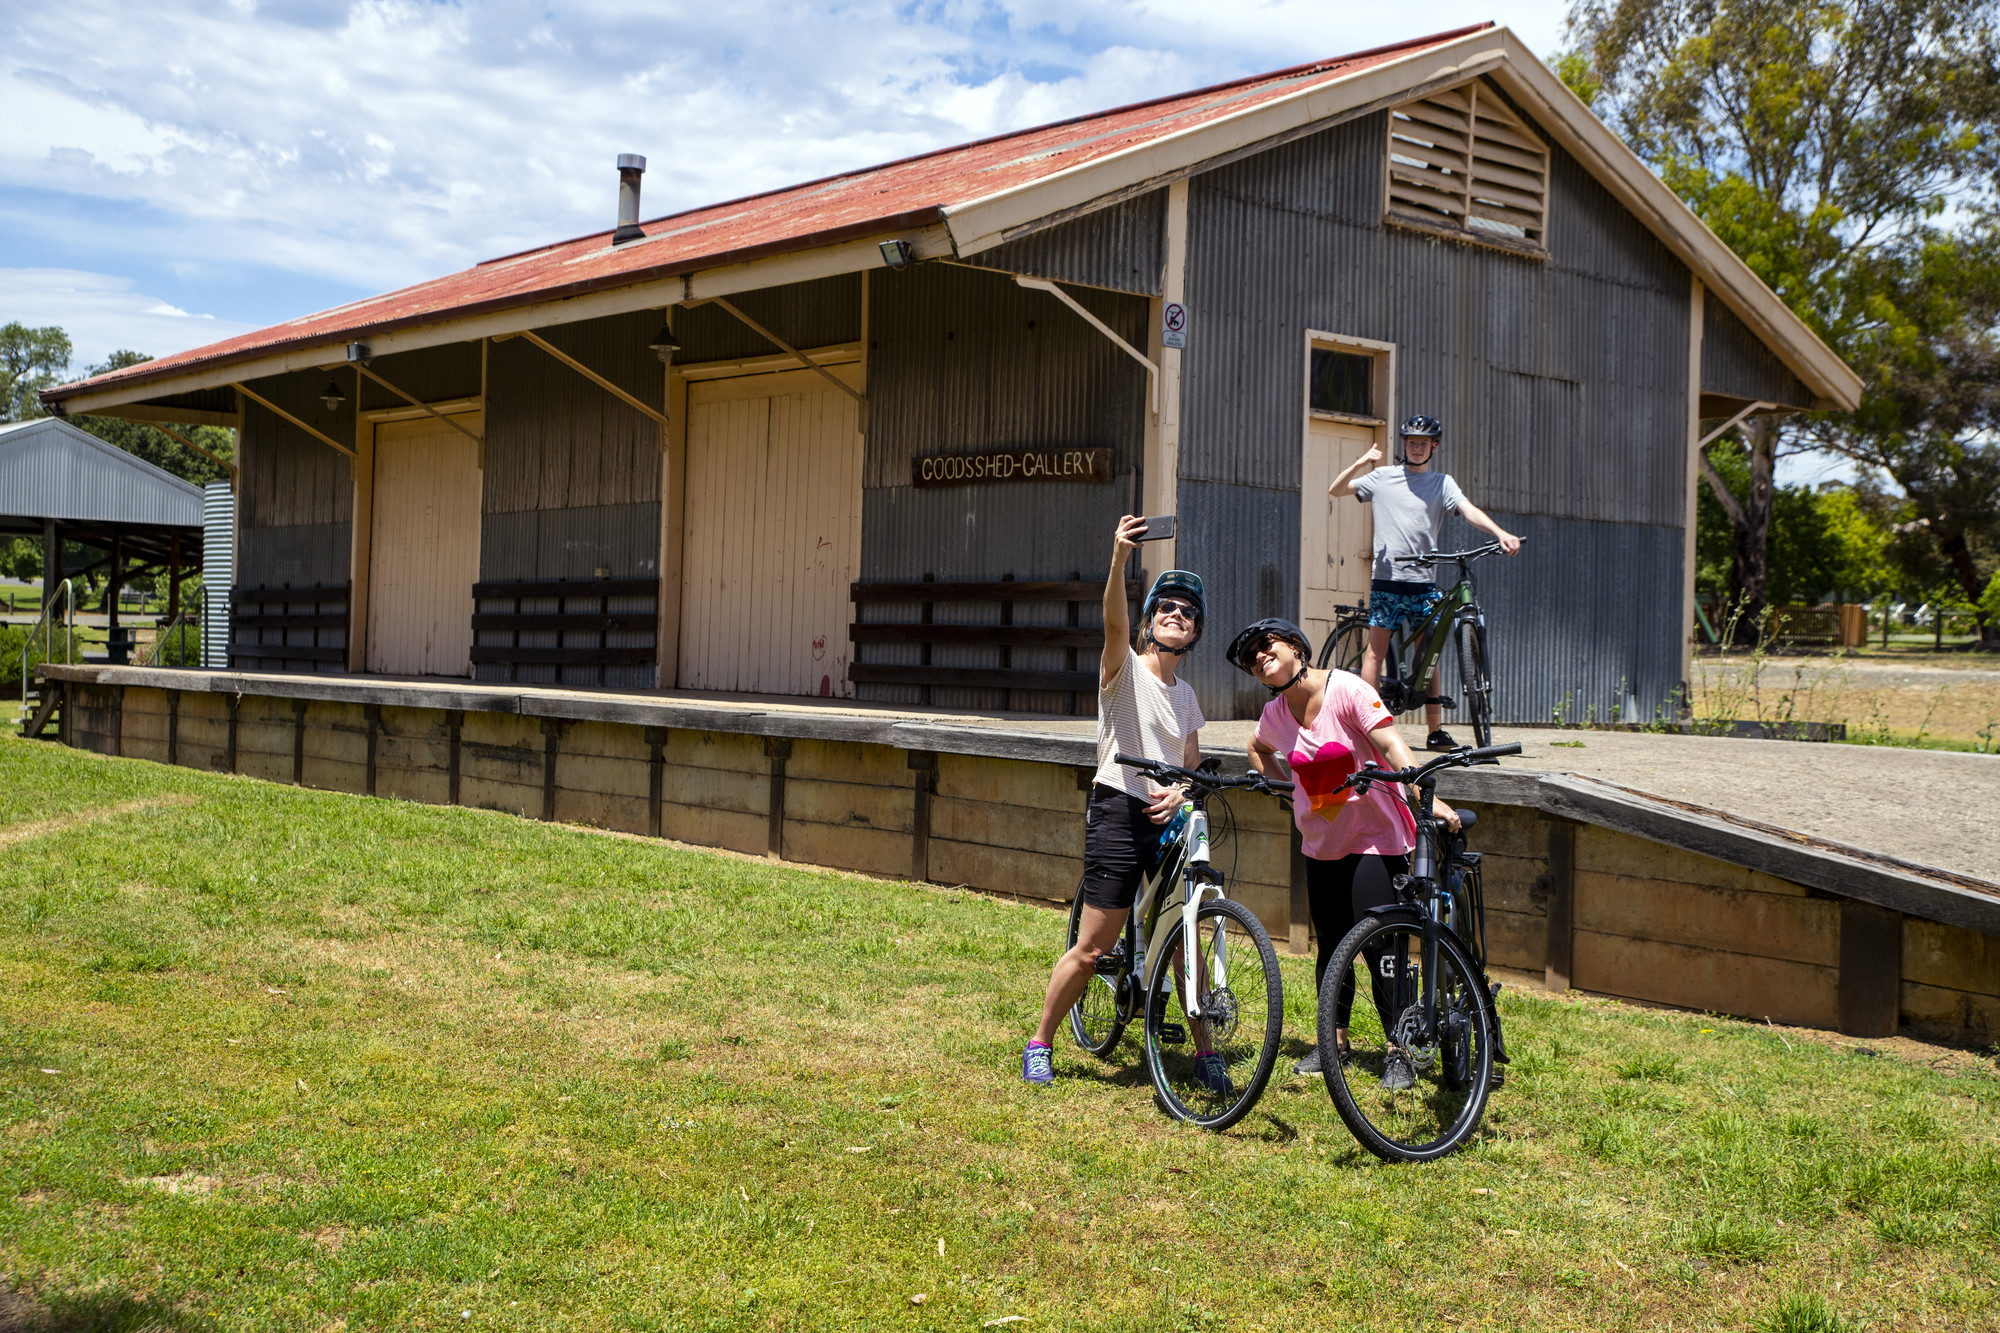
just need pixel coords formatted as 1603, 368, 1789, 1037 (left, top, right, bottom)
1146, 899, 1284, 1129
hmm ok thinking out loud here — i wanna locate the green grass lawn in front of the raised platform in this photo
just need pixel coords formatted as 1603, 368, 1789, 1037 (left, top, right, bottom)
0, 739, 2000, 1331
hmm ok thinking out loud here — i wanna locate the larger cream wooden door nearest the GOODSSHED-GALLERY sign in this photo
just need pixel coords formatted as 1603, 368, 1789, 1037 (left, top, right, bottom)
678, 368, 862, 697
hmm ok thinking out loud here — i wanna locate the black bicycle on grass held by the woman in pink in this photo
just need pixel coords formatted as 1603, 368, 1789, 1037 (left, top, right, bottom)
1318, 745, 1520, 1161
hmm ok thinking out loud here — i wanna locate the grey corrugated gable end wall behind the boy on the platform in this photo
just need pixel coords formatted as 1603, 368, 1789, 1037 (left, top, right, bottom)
1180, 116, 1688, 721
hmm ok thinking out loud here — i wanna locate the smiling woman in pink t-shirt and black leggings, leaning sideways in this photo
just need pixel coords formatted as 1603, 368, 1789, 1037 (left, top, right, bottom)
1228, 618, 1458, 1087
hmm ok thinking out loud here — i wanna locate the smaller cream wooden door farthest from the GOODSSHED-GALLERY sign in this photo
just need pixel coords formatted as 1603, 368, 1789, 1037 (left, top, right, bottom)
368, 412, 480, 677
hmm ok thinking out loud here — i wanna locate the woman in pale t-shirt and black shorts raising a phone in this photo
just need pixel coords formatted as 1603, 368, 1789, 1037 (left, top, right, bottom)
1020, 514, 1228, 1083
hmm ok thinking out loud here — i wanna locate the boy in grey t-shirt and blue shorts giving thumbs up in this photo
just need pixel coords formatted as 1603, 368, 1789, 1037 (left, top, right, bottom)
1326, 416, 1520, 751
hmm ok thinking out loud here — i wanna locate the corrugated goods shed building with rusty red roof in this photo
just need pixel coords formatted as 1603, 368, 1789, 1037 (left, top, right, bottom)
44, 26, 1858, 721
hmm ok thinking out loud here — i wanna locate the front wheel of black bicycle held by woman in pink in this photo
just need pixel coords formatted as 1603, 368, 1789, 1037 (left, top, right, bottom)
1320, 911, 1494, 1161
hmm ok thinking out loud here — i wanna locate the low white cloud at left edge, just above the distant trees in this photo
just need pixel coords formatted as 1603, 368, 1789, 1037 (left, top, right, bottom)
0, 268, 252, 374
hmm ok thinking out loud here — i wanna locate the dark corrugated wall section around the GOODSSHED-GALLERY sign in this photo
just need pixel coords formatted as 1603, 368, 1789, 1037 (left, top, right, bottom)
856, 260, 1144, 709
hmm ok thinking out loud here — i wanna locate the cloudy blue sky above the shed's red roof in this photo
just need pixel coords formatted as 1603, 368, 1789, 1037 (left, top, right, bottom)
0, 0, 1566, 370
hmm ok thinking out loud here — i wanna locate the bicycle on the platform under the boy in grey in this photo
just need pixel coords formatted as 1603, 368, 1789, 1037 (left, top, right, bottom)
1318, 542, 1500, 747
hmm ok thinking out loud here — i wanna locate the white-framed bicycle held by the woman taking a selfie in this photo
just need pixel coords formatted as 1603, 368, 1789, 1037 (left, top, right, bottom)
1068, 755, 1292, 1129
